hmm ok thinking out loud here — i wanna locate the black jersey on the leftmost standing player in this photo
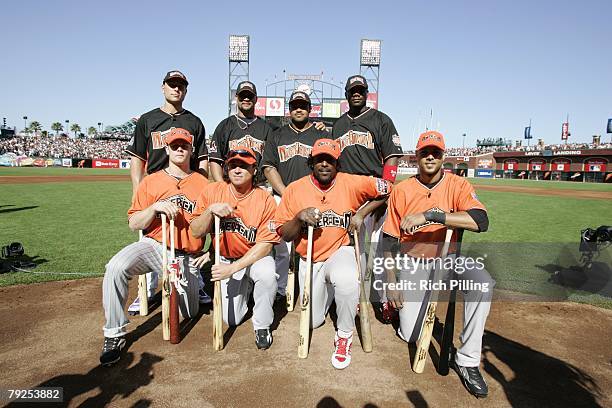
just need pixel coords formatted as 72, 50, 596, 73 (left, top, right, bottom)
125, 108, 208, 174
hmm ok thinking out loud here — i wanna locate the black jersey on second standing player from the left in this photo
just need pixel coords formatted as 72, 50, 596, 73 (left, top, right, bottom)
208, 115, 272, 164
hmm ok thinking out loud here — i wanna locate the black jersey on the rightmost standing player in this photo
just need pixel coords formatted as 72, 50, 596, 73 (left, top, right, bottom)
332, 108, 404, 177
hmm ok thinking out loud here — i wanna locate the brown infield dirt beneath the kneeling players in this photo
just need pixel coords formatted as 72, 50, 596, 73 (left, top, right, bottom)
0, 278, 612, 407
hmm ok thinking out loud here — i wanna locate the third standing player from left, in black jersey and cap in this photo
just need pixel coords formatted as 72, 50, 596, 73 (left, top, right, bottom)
261, 91, 329, 297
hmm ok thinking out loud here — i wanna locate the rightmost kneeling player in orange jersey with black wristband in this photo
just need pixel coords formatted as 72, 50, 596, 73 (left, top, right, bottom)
383, 131, 495, 397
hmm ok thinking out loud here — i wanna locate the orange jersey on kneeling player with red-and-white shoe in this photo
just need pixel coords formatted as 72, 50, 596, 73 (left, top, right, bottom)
275, 173, 392, 262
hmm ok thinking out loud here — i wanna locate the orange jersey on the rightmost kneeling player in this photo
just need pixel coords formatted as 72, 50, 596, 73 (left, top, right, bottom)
383, 173, 486, 257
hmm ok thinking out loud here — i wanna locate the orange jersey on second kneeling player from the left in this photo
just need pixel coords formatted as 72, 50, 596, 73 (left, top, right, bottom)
193, 181, 280, 258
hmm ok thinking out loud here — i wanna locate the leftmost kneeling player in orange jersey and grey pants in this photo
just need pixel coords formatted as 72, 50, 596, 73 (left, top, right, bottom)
100, 128, 208, 366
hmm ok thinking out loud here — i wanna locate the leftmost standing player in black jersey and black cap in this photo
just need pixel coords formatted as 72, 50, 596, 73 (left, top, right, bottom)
126, 70, 211, 313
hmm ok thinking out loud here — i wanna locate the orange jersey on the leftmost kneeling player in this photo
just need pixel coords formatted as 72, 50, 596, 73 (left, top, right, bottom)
128, 170, 208, 253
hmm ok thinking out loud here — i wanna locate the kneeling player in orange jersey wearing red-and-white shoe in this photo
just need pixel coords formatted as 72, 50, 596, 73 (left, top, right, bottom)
275, 139, 392, 369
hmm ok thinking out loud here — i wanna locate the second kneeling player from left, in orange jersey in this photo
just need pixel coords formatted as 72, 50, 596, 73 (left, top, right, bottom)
191, 146, 279, 350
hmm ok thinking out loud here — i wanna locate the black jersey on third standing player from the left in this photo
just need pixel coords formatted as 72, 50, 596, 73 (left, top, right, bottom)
261, 125, 329, 190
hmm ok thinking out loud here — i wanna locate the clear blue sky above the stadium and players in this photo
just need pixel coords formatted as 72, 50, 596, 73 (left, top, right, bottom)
0, 0, 612, 149
